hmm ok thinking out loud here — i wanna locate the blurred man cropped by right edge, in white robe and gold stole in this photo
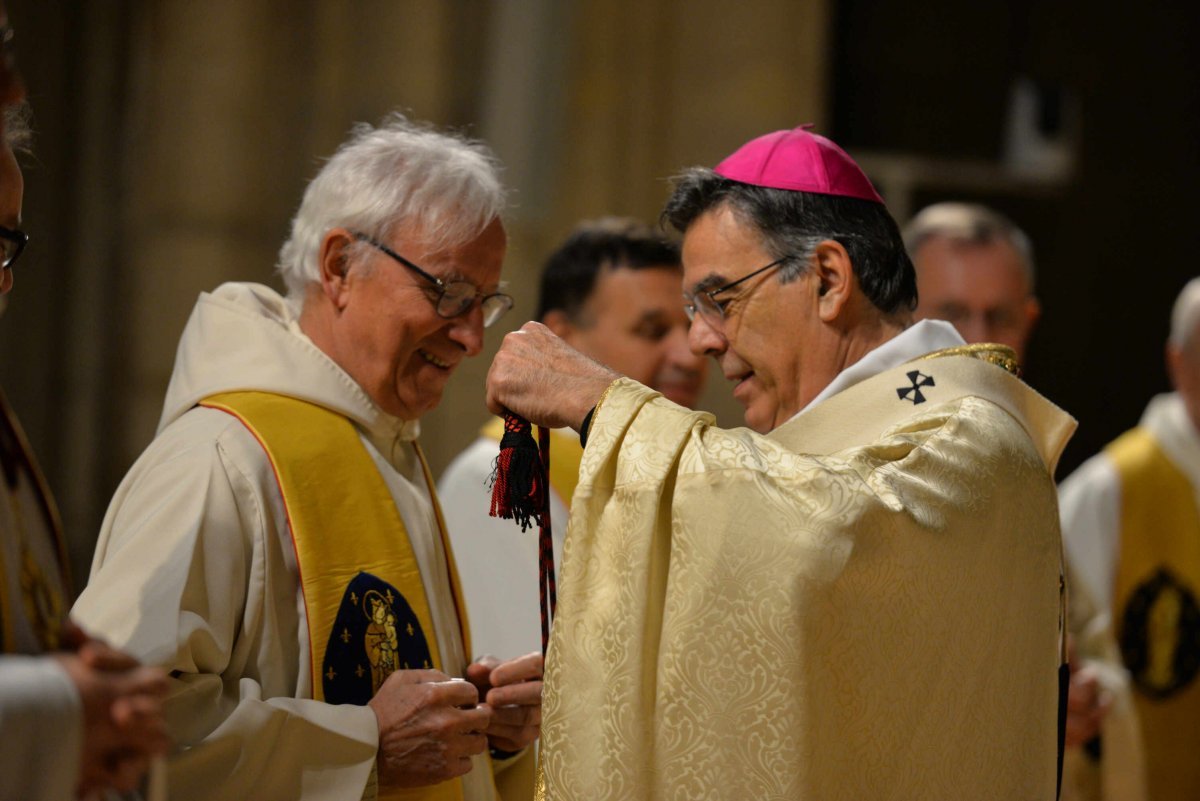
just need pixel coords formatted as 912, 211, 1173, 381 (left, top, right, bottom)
1061, 278, 1200, 801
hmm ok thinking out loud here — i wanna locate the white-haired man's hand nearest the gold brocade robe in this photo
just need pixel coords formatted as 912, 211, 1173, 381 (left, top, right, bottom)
467, 652, 542, 752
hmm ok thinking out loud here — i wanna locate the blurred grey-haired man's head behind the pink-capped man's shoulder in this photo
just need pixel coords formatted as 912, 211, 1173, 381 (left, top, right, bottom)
904, 203, 1042, 365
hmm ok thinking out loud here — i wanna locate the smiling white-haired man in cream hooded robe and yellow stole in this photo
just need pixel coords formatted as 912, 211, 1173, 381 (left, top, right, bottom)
76, 115, 541, 801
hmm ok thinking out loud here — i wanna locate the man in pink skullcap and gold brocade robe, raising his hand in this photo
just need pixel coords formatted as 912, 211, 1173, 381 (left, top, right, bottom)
487, 127, 1075, 801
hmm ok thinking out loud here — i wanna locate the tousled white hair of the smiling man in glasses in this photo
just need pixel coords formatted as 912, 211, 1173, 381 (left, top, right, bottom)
276, 113, 505, 312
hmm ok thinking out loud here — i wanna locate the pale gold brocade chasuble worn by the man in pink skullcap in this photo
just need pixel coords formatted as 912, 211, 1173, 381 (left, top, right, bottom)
539, 349, 1074, 801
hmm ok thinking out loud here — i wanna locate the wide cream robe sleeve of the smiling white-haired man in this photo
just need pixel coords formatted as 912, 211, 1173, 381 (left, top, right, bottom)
73, 410, 378, 801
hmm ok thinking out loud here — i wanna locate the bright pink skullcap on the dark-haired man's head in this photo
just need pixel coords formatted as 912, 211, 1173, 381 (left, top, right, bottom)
713, 125, 883, 203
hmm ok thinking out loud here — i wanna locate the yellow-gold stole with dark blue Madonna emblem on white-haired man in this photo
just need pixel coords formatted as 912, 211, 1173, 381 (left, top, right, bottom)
200, 392, 470, 801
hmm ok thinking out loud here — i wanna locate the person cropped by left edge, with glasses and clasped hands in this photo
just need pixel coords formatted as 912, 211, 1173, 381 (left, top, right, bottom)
0, 4, 167, 801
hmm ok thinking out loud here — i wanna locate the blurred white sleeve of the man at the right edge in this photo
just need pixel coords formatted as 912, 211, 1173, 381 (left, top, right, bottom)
1058, 453, 1121, 612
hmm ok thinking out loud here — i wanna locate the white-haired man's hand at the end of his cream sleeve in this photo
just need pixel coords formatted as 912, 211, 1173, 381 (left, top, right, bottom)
367, 670, 492, 787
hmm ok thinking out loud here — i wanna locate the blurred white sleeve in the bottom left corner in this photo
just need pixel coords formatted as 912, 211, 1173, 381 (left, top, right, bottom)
0, 656, 83, 801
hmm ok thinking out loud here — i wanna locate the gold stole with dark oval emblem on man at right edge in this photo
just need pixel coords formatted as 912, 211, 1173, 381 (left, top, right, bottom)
1104, 428, 1200, 800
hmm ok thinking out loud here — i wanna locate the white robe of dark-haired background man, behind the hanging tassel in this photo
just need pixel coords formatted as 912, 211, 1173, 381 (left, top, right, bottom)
438, 438, 566, 660
